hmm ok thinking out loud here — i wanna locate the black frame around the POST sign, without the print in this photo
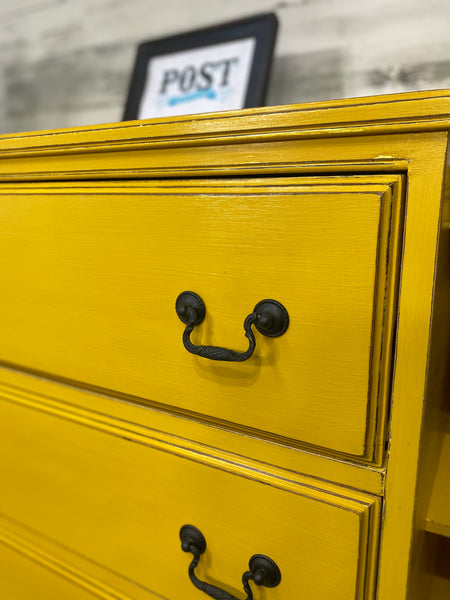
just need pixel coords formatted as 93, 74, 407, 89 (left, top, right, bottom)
123, 13, 278, 121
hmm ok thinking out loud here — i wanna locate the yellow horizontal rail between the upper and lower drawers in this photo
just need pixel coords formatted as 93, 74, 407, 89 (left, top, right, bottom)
0, 367, 385, 496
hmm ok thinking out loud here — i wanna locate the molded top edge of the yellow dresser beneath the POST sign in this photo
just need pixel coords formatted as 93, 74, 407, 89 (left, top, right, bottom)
0, 89, 450, 157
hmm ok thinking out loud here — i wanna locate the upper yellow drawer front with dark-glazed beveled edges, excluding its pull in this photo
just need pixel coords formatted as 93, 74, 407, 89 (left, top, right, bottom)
1, 175, 402, 465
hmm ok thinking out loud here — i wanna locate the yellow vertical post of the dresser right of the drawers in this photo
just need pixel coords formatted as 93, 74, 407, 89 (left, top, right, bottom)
378, 134, 447, 598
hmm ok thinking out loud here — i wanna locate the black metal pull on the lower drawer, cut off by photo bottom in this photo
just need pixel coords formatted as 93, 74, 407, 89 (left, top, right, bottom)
180, 525, 281, 600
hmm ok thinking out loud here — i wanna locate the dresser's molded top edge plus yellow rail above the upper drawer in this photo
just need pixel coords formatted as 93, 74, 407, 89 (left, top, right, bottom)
0, 90, 450, 181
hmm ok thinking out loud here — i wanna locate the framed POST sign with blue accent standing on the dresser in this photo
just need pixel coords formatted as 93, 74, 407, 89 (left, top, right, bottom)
123, 13, 278, 121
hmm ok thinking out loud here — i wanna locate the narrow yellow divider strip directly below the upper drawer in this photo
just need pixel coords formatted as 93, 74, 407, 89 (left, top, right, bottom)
0, 367, 385, 496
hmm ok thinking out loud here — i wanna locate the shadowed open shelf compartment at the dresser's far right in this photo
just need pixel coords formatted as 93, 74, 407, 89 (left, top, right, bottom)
409, 165, 450, 600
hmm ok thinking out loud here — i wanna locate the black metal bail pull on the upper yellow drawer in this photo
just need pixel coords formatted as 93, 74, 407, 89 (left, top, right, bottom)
175, 292, 289, 362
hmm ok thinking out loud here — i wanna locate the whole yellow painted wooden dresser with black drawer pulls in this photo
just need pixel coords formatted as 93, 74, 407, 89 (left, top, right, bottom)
0, 91, 450, 600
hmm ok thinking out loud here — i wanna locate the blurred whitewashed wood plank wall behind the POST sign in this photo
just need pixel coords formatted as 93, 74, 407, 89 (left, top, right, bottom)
0, 0, 450, 133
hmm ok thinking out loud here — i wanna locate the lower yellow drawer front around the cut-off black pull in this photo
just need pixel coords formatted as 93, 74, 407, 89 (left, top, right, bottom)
0, 388, 379, 600
